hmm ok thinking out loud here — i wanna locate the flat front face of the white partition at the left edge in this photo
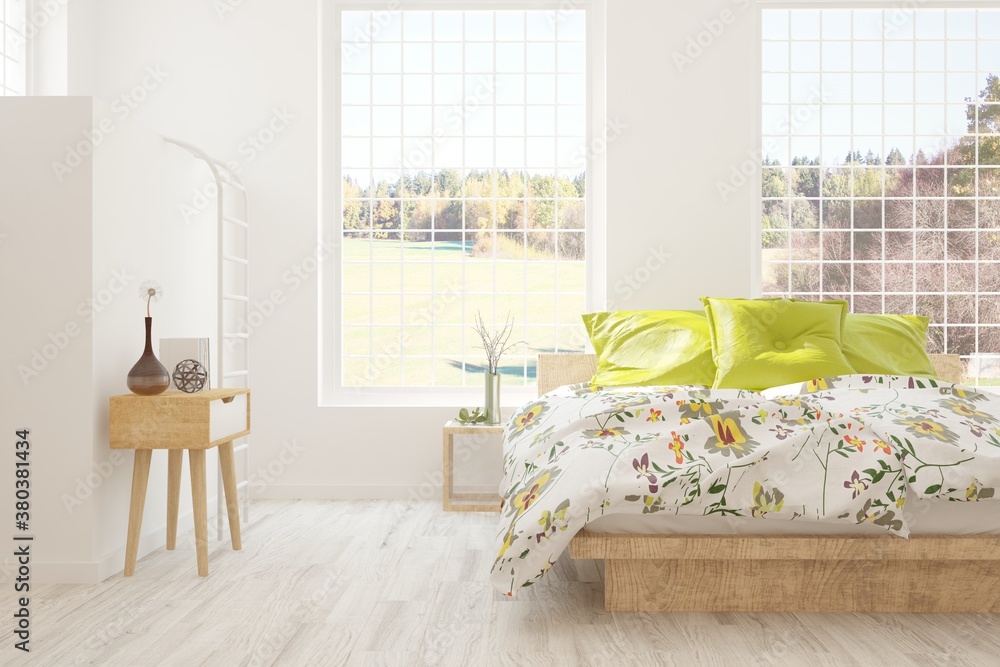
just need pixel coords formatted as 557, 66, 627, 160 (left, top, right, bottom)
0, 97, 96, 587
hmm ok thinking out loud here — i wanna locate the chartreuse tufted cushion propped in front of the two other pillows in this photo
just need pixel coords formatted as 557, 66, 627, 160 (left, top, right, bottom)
701, 297, 854, 390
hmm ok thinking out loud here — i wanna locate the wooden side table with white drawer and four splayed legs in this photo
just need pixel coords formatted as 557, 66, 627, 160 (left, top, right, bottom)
110, 389, 250, 577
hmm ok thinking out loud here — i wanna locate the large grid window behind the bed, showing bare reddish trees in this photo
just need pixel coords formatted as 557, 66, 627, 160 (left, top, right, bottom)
762, 9, 1000, 383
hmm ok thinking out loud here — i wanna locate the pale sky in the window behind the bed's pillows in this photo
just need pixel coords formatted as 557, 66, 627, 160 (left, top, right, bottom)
761, 9, 1000, 164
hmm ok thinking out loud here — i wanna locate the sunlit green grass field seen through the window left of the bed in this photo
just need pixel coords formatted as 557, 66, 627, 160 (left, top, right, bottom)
343, 238, 586, 387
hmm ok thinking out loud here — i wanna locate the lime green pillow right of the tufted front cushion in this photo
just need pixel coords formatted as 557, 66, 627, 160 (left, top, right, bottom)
844, 313, 937, 377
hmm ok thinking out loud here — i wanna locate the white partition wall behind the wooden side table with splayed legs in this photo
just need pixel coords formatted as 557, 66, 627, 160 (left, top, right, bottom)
0, 97, 216, 583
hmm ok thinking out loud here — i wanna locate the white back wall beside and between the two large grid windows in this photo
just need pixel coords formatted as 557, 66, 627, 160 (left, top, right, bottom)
56, 0, 756, 512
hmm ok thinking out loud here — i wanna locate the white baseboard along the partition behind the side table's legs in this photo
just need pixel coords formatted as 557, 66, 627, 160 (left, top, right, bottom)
31, 497, 217, 584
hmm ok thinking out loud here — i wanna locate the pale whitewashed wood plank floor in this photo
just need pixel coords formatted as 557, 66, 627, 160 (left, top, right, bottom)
7, 501, 1000, 667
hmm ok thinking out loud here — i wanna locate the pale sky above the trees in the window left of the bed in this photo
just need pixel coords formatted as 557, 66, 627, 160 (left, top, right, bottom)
341, 10, 587, 186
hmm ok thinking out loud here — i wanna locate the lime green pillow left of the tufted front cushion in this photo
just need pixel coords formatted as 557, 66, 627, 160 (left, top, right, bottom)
583, 310, 715, 387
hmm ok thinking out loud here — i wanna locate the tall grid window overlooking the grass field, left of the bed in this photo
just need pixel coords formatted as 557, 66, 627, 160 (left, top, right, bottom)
340, 9, 587, 387
